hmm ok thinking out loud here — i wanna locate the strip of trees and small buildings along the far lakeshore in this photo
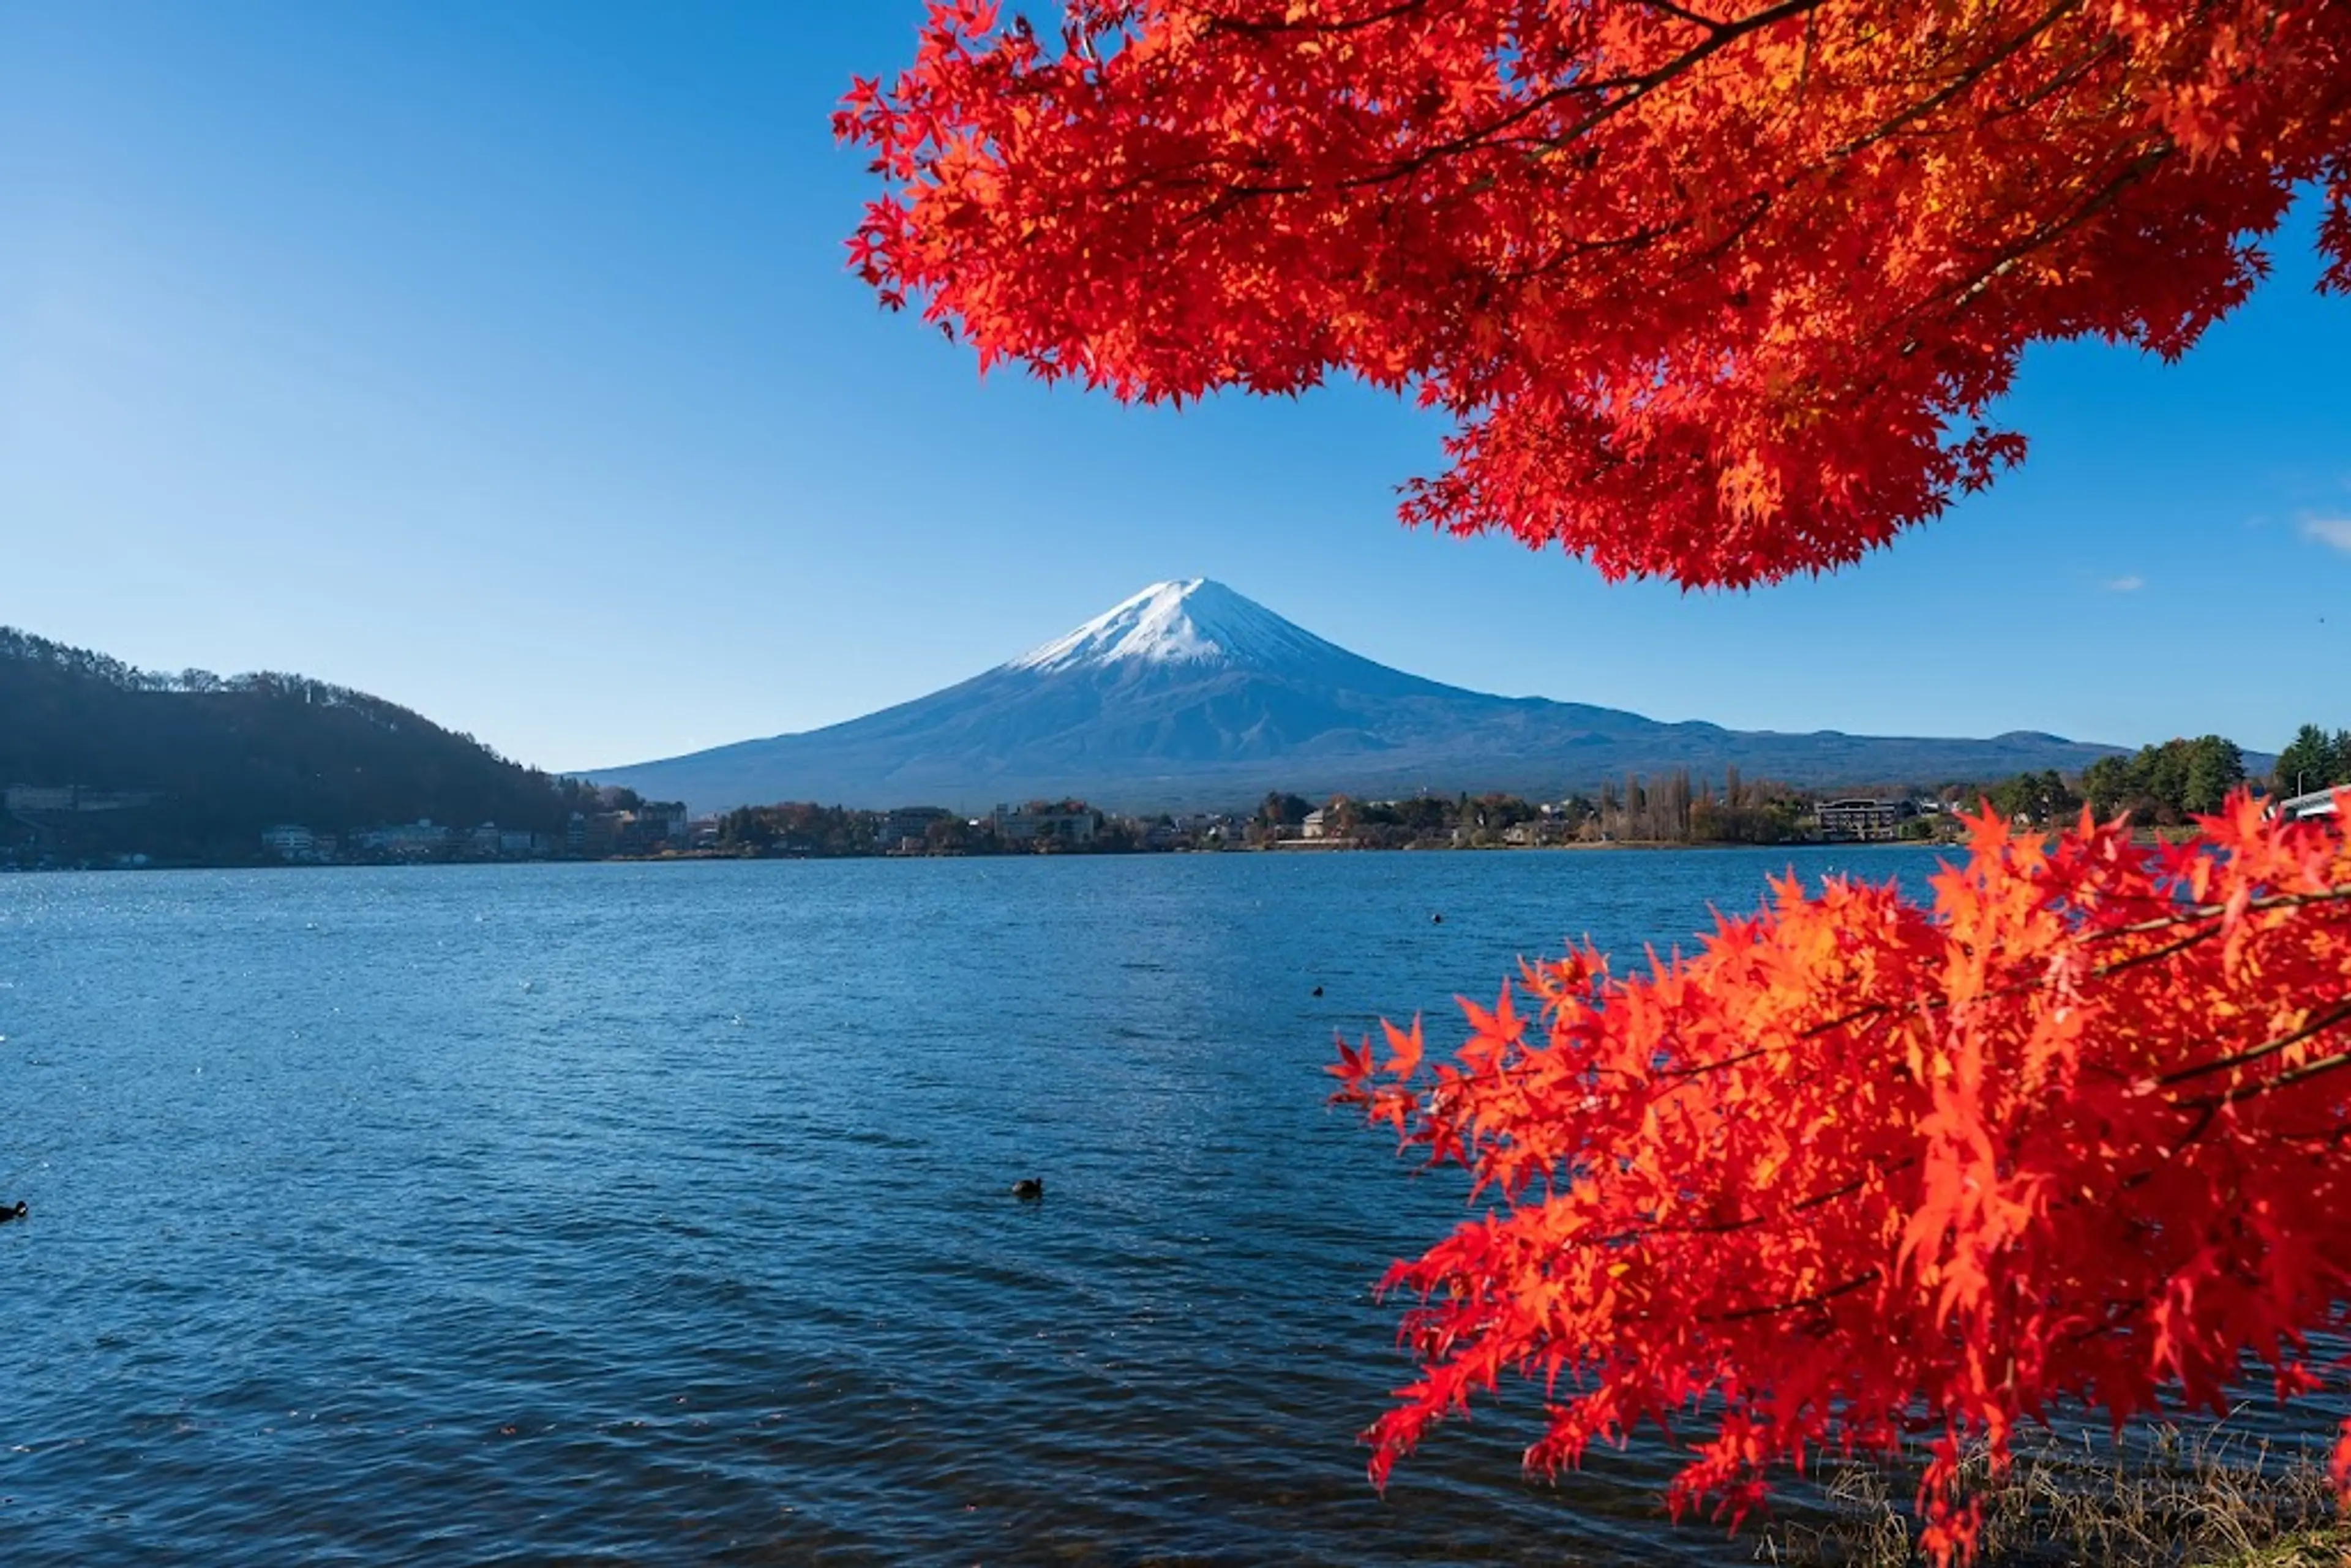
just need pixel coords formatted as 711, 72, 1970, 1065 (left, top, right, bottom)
13, 731, 2351, 870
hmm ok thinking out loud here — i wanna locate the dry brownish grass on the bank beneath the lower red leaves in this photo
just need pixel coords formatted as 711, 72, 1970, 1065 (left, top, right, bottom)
1756, 1425, 2351, 1568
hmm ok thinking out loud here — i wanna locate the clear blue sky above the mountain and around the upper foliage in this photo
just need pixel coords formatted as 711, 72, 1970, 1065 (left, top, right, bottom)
0, 0, 2351, 767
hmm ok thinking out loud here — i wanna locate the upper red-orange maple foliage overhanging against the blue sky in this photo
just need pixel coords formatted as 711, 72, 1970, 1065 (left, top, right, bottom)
834, 0, 2351, 585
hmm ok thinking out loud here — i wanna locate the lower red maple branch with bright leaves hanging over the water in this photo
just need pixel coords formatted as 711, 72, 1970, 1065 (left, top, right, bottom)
1333, 790, 2351, 1563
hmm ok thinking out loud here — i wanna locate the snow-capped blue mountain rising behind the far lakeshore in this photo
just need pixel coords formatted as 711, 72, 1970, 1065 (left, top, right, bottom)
588, 579, 2116, 811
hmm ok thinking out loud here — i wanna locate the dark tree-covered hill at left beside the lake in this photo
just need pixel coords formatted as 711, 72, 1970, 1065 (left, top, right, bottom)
0, 628, 595, 863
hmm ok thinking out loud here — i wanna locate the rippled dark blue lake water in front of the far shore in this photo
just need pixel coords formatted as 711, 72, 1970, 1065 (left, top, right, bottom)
0, 851, 2313, 1568
